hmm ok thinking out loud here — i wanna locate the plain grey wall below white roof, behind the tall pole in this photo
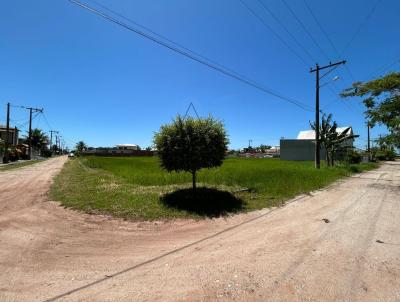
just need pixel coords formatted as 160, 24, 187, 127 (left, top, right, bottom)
280, 139, 325, 160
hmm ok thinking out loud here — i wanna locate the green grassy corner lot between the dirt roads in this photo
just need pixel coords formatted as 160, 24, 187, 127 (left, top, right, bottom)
50, 157, 376, 220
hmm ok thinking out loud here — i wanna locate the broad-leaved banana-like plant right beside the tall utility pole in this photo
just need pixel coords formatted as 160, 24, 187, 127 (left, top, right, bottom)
310, 114, 358, 166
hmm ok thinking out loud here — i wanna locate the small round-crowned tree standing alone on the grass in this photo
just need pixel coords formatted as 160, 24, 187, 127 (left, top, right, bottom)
154, 116, 229, 191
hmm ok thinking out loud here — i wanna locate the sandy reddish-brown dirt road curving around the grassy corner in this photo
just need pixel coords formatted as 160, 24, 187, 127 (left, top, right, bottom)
0, 158, 400, 301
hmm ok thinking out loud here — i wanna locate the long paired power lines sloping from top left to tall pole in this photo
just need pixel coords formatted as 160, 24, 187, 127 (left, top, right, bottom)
68, 0, 312, 111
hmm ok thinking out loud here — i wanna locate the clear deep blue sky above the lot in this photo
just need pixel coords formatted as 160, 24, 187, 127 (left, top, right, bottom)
0, 0, 400, 148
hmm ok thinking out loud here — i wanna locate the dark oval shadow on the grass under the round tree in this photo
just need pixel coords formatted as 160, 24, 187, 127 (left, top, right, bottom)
160, 188, 244, 217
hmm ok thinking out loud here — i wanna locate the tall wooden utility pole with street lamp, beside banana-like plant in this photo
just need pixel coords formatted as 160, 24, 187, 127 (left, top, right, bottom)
310, 60, 346, 169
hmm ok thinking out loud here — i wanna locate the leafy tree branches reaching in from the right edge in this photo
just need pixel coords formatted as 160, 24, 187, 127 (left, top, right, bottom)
341, 72, 400, 148
